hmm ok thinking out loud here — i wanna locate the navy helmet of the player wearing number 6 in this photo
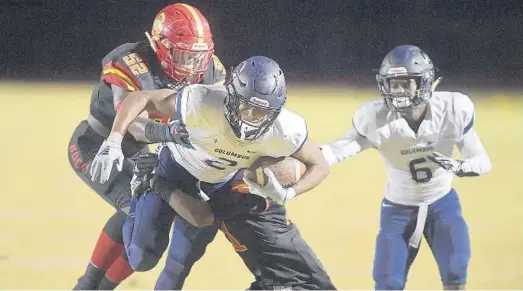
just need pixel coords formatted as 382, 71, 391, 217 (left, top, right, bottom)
376, 45, 439, 112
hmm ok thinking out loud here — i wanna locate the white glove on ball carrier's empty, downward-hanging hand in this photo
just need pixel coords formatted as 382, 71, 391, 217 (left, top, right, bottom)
91, 133, 124, 184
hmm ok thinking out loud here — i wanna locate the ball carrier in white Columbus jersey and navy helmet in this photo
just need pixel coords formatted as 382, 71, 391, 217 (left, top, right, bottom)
91, 56, 329, 289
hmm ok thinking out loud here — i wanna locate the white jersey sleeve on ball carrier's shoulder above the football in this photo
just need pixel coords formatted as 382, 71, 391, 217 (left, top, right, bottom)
262, 108, 308, 158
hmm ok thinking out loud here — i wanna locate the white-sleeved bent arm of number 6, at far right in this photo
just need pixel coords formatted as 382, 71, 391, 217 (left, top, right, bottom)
456, 128, 492, 177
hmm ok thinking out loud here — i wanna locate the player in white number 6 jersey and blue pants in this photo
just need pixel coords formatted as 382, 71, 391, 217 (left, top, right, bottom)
322, 45, 491, 290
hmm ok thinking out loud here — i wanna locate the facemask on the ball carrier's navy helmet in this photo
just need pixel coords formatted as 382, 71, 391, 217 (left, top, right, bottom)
225, 84, 281, 141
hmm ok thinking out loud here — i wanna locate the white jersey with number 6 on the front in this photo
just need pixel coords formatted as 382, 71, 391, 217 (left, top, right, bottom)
322, 92, 474, 205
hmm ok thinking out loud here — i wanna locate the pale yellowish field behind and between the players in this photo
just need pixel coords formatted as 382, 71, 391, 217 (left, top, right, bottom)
0, 83, 523, 289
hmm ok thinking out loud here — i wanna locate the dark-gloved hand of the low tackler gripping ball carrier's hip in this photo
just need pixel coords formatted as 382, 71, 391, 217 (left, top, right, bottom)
131, 153, 159, 197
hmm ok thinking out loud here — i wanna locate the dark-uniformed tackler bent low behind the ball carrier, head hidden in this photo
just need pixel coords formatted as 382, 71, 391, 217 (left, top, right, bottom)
132, 152, 336, 290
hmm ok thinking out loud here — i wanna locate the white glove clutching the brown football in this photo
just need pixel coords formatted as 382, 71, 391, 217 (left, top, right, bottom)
243, 168, 296, 205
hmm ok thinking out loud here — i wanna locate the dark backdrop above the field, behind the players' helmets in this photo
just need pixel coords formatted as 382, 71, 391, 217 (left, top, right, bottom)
0, 0, 523, 86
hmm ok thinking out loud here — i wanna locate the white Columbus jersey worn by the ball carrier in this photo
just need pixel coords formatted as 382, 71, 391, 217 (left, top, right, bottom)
167, 84, 307, 183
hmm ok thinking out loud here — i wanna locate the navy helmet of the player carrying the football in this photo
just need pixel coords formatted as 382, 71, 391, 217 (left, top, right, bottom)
225, 56, 287, 140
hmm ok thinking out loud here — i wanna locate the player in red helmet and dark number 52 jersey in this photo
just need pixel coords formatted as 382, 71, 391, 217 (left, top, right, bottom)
69, 4, 225, 290
